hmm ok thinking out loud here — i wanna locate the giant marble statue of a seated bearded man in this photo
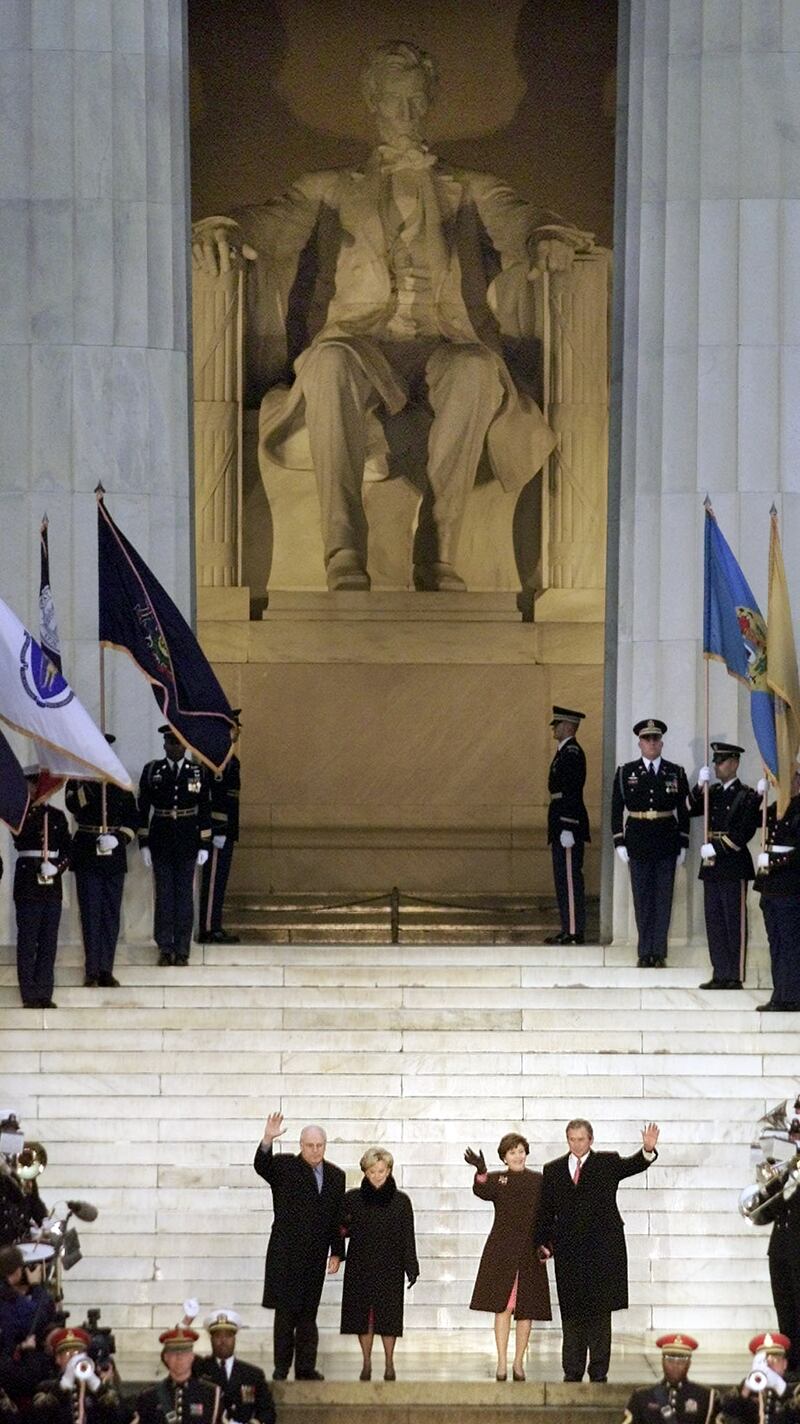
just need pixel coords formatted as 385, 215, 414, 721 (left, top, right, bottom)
192, 43, 592, 591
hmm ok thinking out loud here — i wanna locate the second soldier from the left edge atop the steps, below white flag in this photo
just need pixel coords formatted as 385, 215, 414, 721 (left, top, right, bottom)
64, 732, 138, 988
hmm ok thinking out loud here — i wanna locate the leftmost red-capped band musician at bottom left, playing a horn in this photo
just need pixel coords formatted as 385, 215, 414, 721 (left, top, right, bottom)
30, 1326, 121, 1424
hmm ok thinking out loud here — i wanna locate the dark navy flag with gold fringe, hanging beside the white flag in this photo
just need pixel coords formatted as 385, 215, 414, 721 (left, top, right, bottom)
97, 497, 236, 770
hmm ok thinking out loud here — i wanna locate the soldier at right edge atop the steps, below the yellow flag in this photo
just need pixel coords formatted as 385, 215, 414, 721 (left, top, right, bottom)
756, 770, 800, 1014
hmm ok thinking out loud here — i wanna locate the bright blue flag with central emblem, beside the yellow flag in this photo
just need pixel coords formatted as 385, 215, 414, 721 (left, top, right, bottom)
703, 501, 777, 776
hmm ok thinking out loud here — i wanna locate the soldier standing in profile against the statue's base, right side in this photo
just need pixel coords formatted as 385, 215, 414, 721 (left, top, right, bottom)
545, 708, 589, 944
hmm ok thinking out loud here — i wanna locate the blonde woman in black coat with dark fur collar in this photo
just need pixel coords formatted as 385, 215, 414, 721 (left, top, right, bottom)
335, 1148, 420, 1380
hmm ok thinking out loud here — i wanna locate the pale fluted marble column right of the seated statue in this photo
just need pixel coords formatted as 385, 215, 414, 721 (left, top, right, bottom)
606, 0, 800, 940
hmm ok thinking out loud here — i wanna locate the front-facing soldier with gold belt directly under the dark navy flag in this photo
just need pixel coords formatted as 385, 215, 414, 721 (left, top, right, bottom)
140, 723, 211, 965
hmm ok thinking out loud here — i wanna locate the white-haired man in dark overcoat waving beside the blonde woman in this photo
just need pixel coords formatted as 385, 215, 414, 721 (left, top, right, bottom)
253, 1112, 344, 1380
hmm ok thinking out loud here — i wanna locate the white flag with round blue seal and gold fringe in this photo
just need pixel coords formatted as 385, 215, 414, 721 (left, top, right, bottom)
0, 598, 132, 790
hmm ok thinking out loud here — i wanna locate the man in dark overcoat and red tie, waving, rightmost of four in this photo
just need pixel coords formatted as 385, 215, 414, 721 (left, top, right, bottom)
534, 1118, 659, 1383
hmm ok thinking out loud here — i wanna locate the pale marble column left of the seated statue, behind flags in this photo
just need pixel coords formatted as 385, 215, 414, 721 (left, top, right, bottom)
0, 0, 192, 945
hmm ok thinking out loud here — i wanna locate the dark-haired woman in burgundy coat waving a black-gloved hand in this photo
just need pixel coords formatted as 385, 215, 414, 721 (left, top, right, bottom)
464, 1132, 551, 1380
